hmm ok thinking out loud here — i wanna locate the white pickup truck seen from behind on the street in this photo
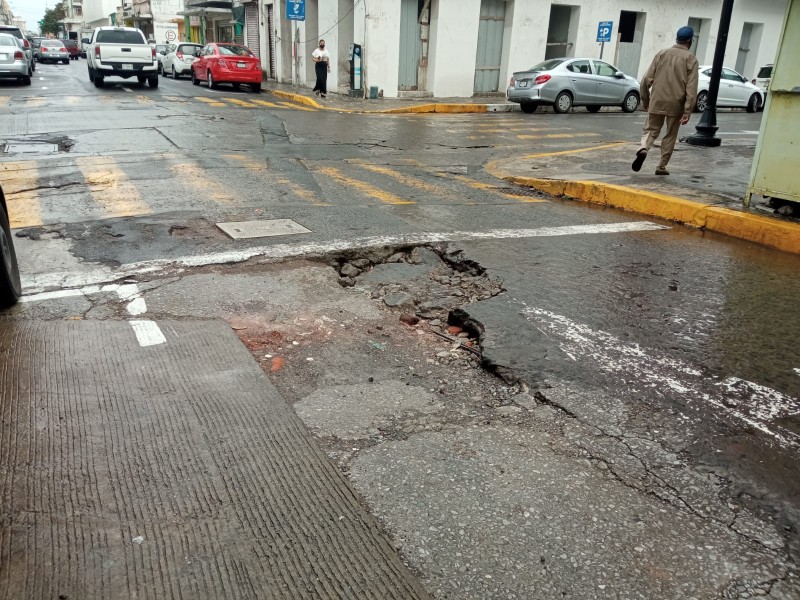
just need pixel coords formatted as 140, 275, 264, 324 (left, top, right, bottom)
86, 27, 158, 88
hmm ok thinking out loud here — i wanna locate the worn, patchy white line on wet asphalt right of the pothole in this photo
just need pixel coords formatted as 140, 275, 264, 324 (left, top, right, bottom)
518, 301, 800, 447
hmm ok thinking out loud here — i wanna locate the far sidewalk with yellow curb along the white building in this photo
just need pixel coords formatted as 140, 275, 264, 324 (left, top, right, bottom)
261, 81, 519, 114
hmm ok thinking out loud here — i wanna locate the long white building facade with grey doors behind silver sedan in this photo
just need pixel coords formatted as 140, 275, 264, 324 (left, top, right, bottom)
256, 0, 787, 97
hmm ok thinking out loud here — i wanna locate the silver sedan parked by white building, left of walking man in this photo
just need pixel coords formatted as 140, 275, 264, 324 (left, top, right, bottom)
506, 58, 639, 113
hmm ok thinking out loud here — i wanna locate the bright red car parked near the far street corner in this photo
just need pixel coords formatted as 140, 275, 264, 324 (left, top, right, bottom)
192, 43, 263, 93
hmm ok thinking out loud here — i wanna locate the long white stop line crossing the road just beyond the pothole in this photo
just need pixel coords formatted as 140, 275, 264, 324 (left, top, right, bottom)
22, 221, 669, 294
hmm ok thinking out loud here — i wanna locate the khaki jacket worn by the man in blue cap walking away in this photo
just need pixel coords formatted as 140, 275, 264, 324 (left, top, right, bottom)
640, 44, 699, 117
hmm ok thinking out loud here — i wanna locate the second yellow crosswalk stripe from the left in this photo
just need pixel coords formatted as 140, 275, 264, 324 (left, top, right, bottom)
75, 156, 152, 218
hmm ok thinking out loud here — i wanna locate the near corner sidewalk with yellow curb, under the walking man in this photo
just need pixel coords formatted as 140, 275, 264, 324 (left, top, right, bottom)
487, 139, 800, 254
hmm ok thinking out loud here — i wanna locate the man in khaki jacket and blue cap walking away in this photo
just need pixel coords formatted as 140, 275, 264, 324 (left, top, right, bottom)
631, 27, 699, 175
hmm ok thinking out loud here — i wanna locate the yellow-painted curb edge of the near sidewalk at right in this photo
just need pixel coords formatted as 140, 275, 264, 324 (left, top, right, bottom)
487, 167, 800, 254
